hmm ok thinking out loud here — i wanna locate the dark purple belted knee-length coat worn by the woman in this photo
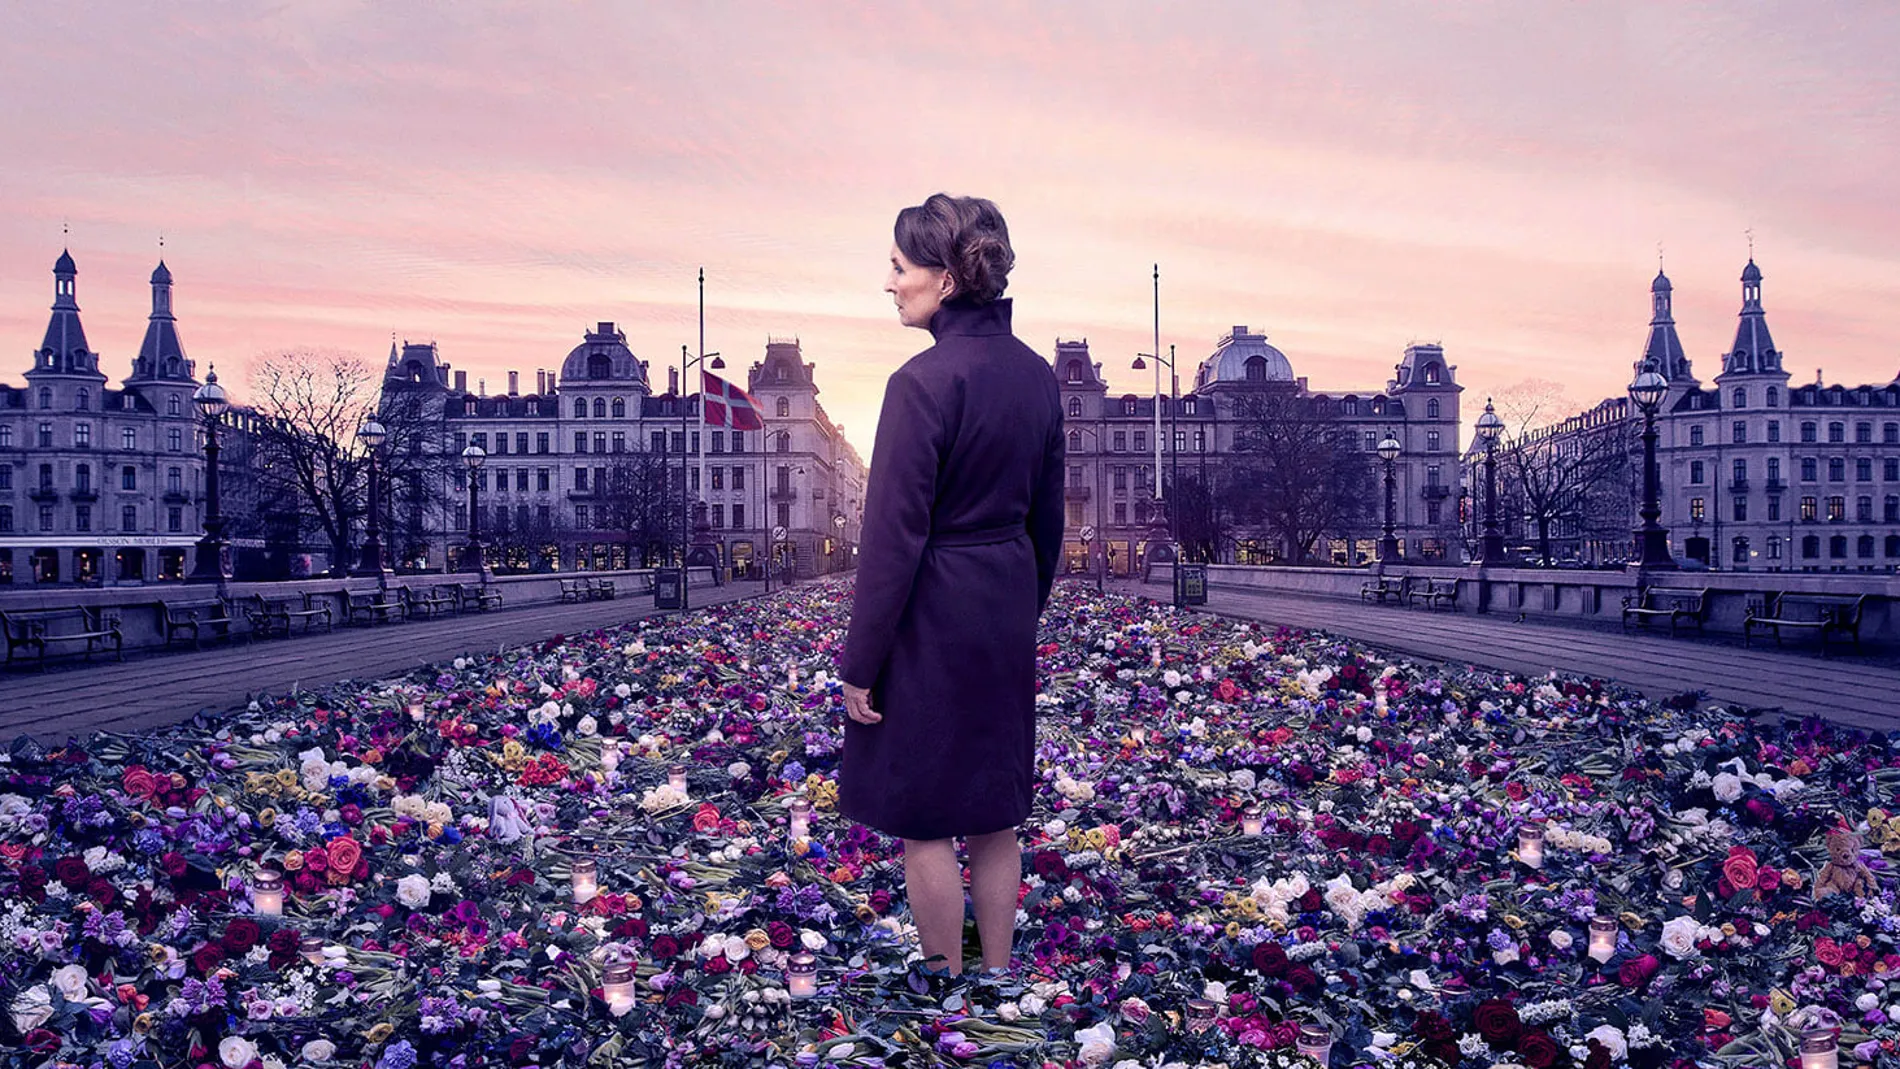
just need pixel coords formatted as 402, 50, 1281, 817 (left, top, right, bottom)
838, 298, 1064, 839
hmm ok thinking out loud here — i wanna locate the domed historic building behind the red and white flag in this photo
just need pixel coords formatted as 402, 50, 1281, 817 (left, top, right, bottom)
382, 323, 866, 575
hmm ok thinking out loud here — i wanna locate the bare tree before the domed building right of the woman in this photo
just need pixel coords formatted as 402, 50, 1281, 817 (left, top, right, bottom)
1229, 387, 1376, 564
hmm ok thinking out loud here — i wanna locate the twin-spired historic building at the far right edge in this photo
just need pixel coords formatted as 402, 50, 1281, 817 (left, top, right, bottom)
1527, 258, 1900, 572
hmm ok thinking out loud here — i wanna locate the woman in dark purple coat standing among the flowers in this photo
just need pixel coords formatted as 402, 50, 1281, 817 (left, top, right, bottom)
838, 194, 1062, 974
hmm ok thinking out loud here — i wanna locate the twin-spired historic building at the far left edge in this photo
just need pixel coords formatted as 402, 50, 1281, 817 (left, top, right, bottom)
0, 253, 224, 583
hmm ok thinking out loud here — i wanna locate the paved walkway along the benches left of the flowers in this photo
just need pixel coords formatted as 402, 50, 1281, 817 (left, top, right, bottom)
0, 583, 777, 742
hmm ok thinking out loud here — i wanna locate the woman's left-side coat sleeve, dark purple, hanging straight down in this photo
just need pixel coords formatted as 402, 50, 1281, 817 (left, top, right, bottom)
838, 370, 944, 687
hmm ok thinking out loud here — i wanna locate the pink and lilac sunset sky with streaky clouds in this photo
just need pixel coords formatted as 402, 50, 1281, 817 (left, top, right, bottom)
0, 0, 1900, 454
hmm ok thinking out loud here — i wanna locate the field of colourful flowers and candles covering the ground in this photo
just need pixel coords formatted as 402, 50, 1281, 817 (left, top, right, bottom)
0, 583, 1900, 1069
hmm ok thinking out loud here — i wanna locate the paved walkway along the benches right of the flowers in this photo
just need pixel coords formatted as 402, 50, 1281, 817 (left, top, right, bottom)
1110, 583, 1900, 731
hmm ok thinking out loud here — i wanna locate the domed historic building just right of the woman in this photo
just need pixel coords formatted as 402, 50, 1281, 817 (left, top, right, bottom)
1055, 327, 1463, 575
